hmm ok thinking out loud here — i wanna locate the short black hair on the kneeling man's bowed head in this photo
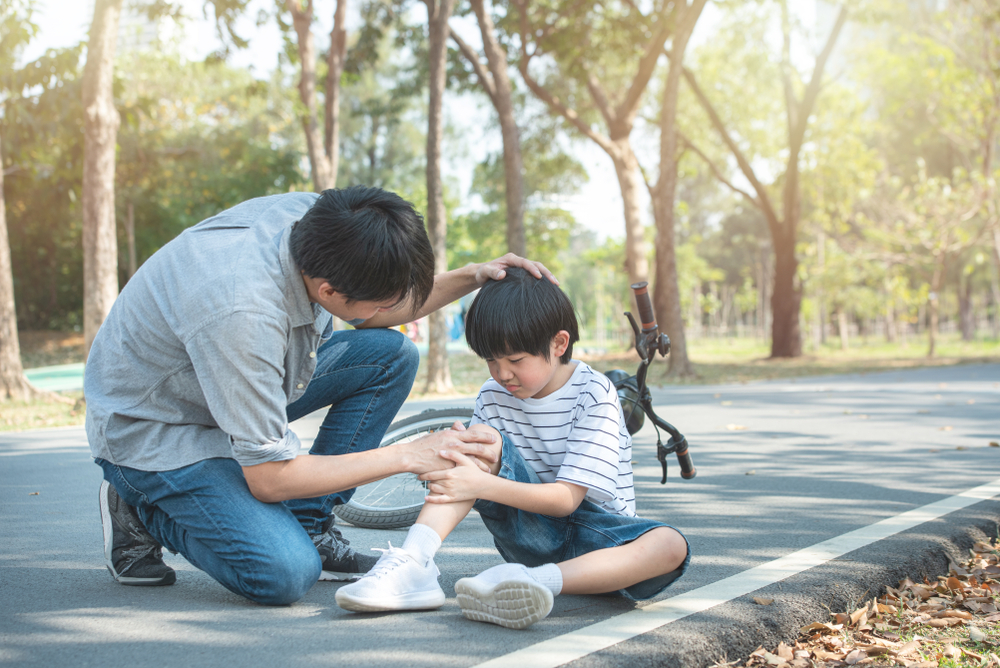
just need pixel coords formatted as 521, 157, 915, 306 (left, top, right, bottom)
289, 186, 434, 309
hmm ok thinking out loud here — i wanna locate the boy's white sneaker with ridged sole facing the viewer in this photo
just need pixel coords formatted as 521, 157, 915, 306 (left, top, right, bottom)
455, 578, 553, 629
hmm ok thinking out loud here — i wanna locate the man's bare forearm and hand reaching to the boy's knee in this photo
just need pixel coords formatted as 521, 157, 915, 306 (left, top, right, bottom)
243, 429, 496, 503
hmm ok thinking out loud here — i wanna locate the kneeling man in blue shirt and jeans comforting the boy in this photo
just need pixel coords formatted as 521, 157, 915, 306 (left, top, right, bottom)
85, 186, 551, 605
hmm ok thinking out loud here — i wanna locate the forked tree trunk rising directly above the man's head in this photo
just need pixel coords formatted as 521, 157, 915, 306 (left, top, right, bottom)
285, 0, 347, 192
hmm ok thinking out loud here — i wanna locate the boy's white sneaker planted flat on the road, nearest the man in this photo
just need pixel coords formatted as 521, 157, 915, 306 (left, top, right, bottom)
336, 543, 445, 612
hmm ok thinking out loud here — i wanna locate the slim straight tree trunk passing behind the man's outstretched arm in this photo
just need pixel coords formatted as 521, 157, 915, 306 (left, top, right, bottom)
425, 0, 455, 394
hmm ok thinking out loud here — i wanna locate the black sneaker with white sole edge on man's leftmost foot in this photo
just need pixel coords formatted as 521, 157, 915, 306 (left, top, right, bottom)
100, 480, 177, 586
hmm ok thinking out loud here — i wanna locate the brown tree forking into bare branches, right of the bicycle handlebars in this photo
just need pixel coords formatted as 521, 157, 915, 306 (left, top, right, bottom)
684, 0, 847, 358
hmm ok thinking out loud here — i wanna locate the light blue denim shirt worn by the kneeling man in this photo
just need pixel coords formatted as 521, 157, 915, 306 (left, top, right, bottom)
84, 193, 333, 471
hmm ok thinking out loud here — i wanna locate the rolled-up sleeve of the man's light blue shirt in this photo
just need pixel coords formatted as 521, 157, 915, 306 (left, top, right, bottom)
185, 312, 301, 466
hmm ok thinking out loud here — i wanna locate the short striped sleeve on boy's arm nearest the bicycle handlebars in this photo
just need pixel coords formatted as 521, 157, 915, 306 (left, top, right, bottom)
556, 383, 622, 501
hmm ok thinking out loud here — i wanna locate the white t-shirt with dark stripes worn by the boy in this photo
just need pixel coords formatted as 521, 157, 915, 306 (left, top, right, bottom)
472, 360, 635, 517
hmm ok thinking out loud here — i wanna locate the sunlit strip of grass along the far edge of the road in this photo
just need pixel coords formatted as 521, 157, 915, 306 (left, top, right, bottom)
0, 332, 1000, 431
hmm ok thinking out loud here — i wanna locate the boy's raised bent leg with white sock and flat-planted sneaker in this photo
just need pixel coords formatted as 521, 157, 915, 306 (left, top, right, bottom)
336, 425, 502, 612
